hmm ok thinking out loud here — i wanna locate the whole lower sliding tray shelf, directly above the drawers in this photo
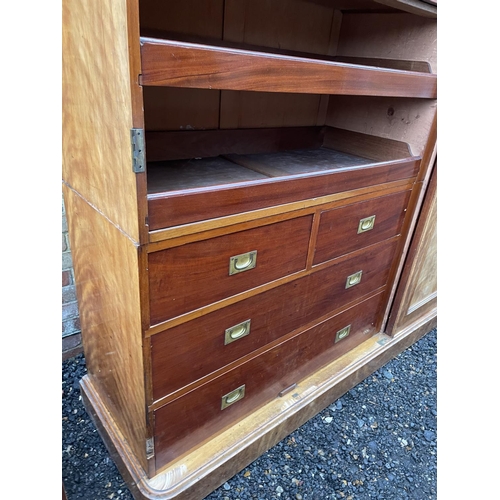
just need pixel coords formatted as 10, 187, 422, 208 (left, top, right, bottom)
146, 127, 420, 231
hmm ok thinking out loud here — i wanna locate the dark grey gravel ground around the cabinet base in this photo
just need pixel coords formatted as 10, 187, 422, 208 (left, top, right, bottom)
62, 330, 437, 500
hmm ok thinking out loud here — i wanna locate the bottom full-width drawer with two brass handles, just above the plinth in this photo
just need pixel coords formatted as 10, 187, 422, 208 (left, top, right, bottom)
154, 293, 384, 468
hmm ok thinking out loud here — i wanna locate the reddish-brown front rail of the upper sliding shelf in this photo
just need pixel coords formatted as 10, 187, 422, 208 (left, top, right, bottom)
140, 37, 437, 98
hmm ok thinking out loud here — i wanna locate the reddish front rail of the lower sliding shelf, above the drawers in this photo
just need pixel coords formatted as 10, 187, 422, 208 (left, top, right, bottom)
148, 160, 420, 231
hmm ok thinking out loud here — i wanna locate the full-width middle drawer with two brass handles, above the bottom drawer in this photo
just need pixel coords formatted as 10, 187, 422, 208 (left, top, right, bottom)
151, 235, 397, 400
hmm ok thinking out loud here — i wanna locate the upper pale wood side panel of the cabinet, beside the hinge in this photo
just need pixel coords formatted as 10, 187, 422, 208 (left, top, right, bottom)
62, 0, 139, 241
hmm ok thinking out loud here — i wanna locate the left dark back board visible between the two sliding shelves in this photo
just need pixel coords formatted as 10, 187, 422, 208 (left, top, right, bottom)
143, 87, 220, 132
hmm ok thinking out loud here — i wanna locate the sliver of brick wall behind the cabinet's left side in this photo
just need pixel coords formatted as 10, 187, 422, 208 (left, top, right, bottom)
62, 192, 81, 359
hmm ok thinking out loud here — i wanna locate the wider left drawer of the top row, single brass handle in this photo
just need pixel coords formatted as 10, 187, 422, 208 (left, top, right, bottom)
148, 215, 312, 324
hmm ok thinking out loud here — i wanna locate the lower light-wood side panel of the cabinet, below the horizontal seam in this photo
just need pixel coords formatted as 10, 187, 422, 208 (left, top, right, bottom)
63, 184, 147, 470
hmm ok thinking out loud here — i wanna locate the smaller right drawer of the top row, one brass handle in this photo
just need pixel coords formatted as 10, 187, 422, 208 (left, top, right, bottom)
313, 191, 411, 264
